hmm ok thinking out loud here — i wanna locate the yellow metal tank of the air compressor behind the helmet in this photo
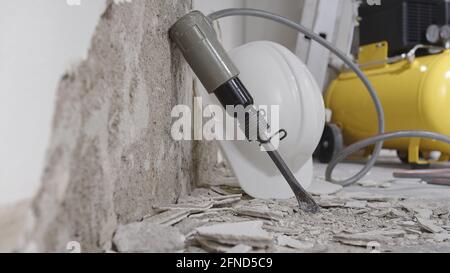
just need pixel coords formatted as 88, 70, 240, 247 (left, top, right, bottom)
321, 42, 450, 165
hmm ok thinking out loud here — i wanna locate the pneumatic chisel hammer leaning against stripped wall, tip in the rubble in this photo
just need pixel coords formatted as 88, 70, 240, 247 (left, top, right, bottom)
169, 11, 319, 212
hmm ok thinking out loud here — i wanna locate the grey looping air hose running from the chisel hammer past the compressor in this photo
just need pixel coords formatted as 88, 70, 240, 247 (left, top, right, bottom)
208, 8, 450, 186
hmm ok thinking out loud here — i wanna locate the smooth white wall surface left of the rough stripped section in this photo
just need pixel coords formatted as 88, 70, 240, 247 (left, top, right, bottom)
0, 0, 105, 204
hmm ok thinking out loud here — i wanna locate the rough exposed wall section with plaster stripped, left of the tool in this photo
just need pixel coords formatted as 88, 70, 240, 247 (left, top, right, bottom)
32, 0, 193, 251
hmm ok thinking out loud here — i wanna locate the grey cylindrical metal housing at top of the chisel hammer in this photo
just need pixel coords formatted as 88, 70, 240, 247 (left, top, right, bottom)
169, 11, 239, 93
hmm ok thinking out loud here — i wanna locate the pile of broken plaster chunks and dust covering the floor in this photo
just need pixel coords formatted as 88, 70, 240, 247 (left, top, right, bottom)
109, 182, 450, 253
